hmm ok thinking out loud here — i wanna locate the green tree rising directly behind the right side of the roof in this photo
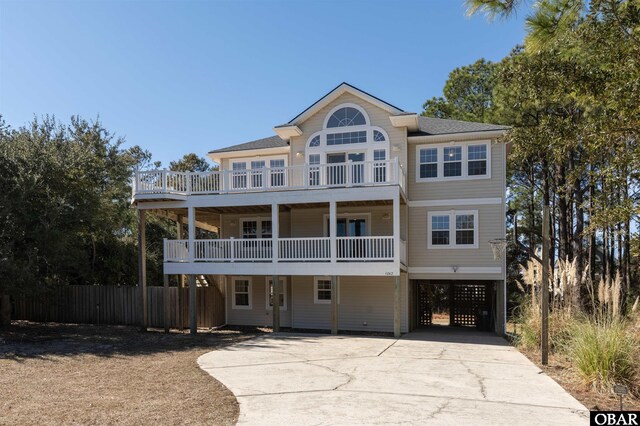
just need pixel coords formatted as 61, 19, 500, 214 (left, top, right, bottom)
422, 59, 497, 122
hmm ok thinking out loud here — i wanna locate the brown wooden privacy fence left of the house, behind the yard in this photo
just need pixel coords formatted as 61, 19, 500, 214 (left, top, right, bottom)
12, 285, 225, 328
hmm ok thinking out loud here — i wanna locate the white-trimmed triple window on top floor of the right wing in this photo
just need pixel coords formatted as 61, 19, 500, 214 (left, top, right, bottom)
416, 142, 491, 182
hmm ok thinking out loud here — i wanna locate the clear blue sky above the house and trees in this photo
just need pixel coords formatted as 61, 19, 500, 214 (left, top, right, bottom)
0, 0, 524, 165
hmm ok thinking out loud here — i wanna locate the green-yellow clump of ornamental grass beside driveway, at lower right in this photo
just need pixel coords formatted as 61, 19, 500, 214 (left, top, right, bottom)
566, 320, 640, 391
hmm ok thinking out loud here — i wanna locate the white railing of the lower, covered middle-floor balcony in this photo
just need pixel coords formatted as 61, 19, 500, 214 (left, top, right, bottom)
164, 236, 394, 262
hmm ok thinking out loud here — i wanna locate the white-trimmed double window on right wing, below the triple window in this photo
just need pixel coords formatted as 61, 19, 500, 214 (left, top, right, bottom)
427, 210, 478, 249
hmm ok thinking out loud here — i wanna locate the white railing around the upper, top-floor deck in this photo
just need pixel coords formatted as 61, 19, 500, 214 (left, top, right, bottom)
133, 158, 406, 196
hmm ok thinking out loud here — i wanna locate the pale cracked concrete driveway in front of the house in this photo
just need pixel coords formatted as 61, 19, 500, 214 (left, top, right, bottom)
198, 328, 589, 425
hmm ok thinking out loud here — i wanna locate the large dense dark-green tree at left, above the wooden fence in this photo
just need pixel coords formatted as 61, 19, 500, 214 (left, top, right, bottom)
0, 117, 171, 324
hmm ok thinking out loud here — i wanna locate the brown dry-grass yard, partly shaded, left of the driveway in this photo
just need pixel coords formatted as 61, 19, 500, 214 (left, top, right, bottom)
0, 322, 260, 425
